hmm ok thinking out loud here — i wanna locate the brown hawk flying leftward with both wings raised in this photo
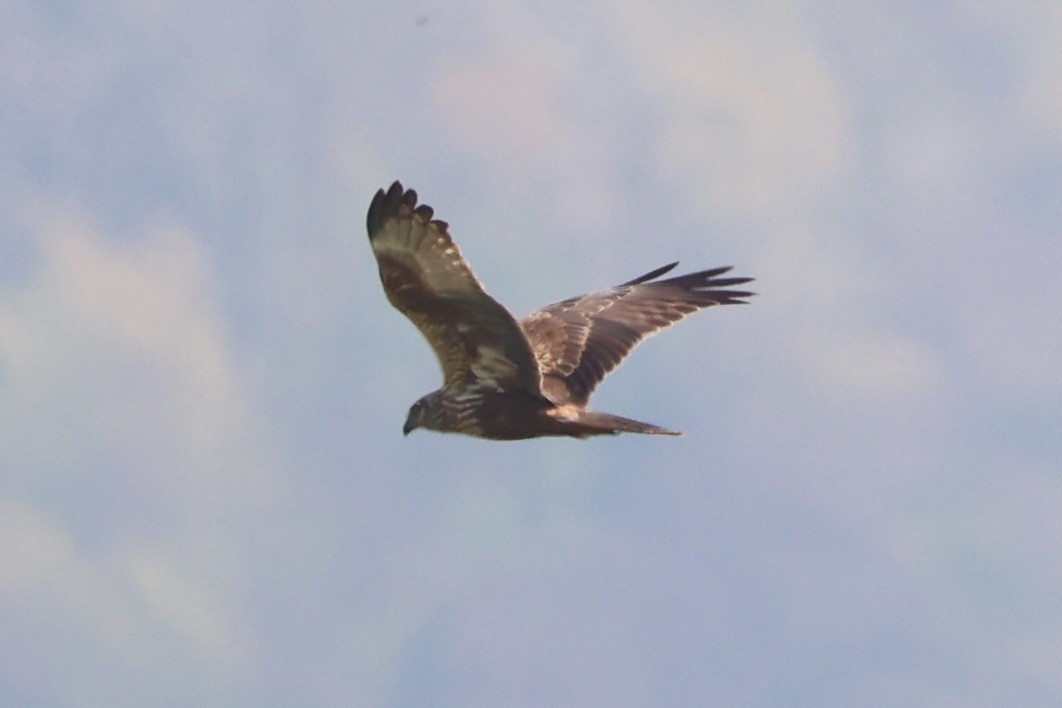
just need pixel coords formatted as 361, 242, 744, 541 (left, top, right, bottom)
366, 182, 753, 441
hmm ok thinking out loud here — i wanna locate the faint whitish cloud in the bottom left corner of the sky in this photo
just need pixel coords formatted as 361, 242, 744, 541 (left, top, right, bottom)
0, 501, 255, 705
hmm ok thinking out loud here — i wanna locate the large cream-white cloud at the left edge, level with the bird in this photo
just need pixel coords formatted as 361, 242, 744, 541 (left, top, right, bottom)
0, 205, 282, 503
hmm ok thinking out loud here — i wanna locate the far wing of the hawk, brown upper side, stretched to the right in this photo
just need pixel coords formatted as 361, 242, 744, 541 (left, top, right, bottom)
520, 262, 753, 404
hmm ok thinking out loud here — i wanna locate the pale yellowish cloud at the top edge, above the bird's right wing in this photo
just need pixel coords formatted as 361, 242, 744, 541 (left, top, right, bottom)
619, 3, 851, 216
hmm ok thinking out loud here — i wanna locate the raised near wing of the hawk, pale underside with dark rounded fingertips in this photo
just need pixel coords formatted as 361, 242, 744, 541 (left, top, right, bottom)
366, 182, 541, 393
